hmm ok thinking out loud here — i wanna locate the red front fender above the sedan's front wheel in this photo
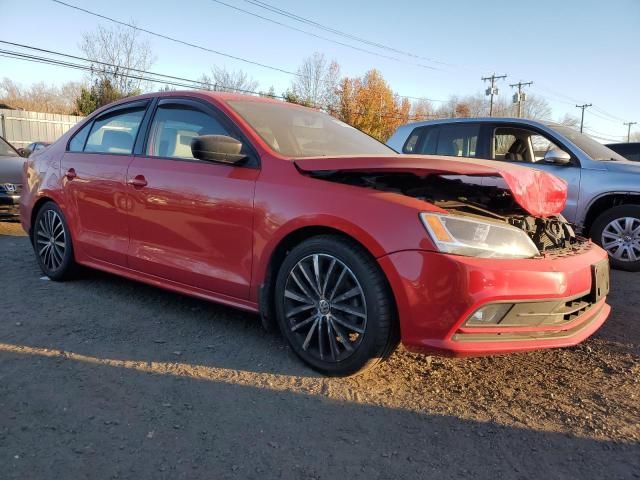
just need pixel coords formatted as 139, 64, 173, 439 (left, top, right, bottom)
251, 159, 442, 300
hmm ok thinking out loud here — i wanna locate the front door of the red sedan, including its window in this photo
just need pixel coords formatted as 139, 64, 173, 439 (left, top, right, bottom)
127, 97, 260, 299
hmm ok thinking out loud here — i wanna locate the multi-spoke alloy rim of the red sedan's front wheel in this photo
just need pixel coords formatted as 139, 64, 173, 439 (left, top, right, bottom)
284, 254, 367, 362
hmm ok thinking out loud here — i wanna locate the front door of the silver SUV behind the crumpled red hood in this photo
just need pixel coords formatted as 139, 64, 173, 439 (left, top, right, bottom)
491, 124, 582, 222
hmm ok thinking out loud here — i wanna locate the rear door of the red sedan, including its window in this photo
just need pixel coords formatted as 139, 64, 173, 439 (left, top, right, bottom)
61, 101, 149, 266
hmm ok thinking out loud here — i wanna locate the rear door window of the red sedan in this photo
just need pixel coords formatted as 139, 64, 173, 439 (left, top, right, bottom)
84, 107, 145, 155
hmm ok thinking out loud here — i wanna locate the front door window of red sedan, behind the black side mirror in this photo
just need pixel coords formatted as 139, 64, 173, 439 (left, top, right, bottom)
146, 105, 229, 159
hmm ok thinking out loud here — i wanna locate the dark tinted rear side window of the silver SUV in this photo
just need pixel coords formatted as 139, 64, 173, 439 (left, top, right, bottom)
419, 124, 480, 157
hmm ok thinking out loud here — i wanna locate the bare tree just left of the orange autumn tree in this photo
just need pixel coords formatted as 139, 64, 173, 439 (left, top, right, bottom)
291, 52, 340, 110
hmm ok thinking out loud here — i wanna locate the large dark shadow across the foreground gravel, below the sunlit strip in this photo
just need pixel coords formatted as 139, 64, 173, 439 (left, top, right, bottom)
0, 340, 640, 479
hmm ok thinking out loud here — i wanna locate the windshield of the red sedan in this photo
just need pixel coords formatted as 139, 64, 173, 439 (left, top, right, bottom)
227, 100, 396, 158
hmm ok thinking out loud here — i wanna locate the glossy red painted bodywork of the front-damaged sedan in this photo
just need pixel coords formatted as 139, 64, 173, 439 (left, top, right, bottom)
21, 92, 608, 355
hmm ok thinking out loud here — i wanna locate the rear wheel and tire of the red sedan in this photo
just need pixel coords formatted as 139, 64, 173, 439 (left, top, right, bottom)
31, 202, 77, 281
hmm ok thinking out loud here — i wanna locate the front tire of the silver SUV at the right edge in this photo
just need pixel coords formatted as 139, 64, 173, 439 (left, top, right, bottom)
590, 205, 640, 272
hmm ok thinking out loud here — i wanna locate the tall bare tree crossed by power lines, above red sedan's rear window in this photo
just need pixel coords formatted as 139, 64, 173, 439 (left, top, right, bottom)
79, 26, 155, 96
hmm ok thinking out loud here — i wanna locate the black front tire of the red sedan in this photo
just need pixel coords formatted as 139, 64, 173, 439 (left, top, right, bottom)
275, 235, 399, 376
